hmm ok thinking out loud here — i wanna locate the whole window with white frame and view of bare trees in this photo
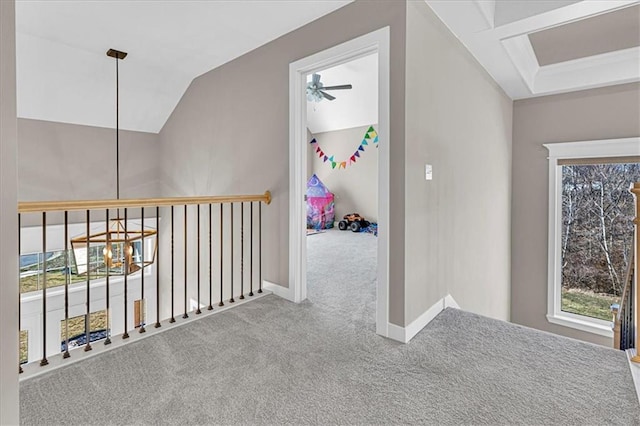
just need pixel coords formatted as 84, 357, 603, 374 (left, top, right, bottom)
545, 138, 640, 336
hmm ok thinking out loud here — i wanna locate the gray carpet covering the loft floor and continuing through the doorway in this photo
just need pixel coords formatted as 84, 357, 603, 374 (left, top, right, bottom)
21, 233, 640, 425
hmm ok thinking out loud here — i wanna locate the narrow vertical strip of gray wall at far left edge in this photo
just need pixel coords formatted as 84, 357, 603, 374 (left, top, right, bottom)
0, 1, 18, 425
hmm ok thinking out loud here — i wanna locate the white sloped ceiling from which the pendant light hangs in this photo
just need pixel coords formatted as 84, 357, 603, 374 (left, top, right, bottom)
16, 0, 350, 133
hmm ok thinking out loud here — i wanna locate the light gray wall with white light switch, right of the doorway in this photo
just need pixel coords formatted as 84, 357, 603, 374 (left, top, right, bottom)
408, 2, 512, 324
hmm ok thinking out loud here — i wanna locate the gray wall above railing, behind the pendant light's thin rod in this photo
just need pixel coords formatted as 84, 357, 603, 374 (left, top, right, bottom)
18, 118, 160, 201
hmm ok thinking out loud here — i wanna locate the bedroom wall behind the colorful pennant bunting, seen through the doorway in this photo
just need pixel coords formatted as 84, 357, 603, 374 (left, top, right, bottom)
307, 124, 378, 222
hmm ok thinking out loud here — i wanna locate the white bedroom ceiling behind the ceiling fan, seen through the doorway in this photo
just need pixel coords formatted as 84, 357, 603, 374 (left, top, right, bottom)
307, 53, 378, 133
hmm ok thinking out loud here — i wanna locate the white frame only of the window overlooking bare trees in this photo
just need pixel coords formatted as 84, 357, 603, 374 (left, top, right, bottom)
543, 137, 640, 337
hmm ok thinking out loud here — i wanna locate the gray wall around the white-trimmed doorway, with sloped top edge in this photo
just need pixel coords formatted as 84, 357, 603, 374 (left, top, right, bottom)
160, 1, 406, 324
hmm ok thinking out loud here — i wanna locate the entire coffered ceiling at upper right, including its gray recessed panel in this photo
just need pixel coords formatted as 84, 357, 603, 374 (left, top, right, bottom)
426, 0, 640, 99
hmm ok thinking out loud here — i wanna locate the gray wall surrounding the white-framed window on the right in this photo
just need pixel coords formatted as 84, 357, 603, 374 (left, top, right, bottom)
511, 83, 640, 346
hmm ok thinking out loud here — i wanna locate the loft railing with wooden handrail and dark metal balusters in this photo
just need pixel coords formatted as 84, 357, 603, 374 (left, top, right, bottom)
18, 191, 271, 373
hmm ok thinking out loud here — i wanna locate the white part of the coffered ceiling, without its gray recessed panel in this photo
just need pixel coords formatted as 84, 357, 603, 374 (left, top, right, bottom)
425, 0, 640, 99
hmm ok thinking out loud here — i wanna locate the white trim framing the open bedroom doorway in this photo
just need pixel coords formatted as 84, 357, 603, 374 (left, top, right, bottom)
289, 27, 390, 336
